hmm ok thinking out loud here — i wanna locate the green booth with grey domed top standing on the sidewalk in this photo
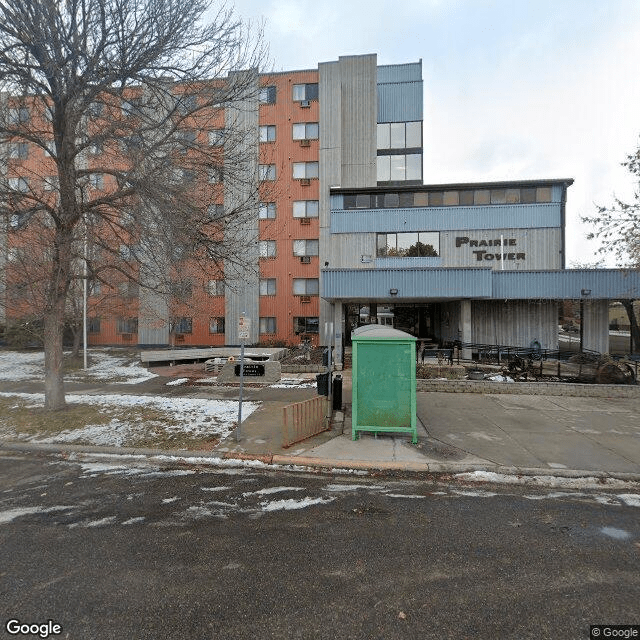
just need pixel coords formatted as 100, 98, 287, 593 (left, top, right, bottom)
351, 324, 418, 444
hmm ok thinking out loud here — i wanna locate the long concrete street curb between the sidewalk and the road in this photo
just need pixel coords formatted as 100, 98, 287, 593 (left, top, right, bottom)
0, 440, 640, 484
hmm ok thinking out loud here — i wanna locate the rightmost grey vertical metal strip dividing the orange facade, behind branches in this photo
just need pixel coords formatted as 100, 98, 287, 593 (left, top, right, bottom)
224, 71, 260, 344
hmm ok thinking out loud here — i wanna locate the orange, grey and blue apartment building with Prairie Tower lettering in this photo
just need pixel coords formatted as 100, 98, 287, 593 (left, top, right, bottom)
0, 54, 640, 363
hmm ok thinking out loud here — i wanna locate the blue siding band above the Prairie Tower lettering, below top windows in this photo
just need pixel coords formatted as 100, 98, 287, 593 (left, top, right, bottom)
331, 203, 561, 233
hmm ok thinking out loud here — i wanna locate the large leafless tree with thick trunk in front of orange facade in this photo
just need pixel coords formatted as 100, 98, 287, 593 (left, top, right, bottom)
0, 0, 265, 409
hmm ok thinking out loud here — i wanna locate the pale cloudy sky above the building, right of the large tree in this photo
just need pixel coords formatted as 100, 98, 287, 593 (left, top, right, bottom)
229, 0, 640, 266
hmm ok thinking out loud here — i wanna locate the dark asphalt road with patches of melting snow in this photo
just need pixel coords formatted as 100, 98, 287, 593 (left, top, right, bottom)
0, 453, 640, 640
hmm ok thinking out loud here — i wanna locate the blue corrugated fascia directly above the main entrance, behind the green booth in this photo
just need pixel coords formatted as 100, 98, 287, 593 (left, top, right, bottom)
321, 269, 491, 300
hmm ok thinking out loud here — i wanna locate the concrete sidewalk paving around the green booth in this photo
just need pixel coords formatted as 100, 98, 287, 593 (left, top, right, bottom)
0, 370, 640, 480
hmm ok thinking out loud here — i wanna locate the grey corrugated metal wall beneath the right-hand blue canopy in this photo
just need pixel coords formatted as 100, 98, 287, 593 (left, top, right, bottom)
471, 300, 558, 349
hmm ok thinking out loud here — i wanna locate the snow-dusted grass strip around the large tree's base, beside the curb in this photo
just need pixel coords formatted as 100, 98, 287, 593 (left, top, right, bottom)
0, 393, 260, 446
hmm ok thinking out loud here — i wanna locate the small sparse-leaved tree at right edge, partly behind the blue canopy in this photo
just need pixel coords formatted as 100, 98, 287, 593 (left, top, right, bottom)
582, 140, 640, 351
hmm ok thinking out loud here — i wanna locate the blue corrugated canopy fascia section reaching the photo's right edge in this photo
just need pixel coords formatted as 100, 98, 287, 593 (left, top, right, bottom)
493, 269, 640, 300
